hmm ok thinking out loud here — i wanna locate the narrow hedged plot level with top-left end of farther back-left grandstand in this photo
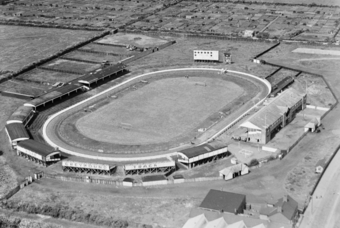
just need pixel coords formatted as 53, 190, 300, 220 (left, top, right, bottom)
44, 59, 100, 74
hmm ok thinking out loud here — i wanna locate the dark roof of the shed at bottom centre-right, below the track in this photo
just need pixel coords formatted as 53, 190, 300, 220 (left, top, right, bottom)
200, 189, 246, 213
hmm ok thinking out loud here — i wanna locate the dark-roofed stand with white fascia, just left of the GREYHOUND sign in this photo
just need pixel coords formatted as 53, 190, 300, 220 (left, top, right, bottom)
16, 139, 60, 166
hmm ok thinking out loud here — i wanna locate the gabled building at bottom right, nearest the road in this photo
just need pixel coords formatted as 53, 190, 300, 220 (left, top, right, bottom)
259, 195, 298, 227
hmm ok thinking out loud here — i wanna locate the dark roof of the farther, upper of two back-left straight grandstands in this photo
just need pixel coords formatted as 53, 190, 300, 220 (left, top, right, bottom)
78, 63, 126, 84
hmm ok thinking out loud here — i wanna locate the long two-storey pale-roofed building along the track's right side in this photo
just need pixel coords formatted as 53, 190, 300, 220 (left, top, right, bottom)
239, 88, 307, 144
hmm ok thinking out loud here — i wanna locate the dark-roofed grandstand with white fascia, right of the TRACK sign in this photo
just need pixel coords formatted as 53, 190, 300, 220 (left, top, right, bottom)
178, 144, 229, 169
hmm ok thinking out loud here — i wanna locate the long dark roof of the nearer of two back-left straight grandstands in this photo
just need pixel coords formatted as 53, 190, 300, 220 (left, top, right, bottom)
25, 84, 82, 107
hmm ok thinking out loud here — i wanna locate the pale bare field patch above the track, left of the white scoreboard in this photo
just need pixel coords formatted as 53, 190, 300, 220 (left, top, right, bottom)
97, 33, 168, 47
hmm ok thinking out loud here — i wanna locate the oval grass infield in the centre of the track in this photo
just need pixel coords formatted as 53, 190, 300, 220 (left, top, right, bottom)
76, 72, 243, 144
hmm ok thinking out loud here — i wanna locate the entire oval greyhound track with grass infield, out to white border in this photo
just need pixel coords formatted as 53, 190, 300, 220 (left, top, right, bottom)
39, 68, 270, 162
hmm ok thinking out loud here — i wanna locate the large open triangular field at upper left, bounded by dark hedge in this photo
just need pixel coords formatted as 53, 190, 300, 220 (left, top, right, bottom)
0, 25, 96, 71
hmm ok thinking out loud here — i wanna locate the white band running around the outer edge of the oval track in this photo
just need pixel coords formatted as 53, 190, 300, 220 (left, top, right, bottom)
43, 68, 271, 162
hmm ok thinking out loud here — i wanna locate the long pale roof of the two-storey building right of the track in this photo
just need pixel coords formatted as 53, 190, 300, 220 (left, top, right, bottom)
241, 88, 305, 130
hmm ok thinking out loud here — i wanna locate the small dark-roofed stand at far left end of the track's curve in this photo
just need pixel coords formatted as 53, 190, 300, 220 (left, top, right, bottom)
5, 123, 30, 149
